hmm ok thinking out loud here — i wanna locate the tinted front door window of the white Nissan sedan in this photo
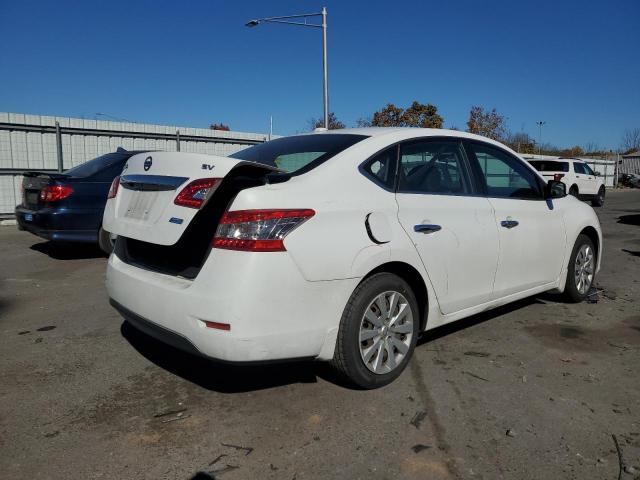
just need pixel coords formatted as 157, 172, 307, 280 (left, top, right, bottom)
470, 143, 542, 199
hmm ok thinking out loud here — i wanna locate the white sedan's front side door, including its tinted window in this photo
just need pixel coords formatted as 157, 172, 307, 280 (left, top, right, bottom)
465, 142, 565, 298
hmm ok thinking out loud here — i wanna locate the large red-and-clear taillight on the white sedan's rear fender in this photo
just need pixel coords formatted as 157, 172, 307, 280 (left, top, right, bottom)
213, 209, 316, 252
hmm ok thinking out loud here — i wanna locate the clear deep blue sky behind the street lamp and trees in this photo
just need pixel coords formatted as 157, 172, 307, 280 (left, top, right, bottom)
0, 0, 640, 149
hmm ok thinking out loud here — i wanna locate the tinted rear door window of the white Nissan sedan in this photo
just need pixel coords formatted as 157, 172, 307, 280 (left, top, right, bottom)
398, 141, 468, 194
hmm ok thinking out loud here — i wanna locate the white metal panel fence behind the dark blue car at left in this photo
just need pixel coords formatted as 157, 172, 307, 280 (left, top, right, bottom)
0, 112, 268, 215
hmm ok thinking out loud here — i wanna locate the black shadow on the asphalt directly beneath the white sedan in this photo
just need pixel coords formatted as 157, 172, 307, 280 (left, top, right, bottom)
120, 294, 558, 393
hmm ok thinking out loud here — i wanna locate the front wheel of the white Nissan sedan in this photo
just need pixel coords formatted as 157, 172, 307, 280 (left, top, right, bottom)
564, 234, 597, 303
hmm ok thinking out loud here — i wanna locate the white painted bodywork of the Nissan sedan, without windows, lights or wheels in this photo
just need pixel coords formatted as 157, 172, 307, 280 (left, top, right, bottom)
104, 128, 602, 362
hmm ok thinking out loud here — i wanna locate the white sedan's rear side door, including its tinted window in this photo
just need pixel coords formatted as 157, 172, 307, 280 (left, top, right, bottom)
396, 137, 498, 314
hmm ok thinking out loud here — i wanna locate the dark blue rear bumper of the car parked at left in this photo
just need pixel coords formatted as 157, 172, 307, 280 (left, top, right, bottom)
15, 205, 102, 243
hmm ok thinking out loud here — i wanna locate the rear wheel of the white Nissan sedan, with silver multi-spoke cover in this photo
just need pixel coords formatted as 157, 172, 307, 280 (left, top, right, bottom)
331, 273, 420, 389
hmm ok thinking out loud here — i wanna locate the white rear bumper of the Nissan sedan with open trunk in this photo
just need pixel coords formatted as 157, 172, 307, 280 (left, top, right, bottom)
107, 249, 358, 363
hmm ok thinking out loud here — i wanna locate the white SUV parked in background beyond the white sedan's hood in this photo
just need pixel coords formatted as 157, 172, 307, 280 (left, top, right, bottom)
529, 158, 606, 207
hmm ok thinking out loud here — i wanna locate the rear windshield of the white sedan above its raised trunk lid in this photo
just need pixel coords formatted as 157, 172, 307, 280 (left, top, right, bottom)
230, 133, 367, 175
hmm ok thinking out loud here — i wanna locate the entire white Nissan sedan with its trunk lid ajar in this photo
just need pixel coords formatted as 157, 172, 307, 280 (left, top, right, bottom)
104, 128, 602, 388
